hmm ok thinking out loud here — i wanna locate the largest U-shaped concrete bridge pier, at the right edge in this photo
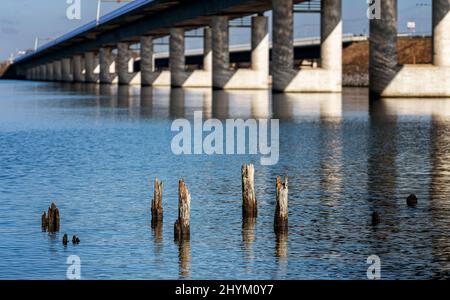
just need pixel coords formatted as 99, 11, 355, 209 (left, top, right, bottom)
369, 0, 450, 97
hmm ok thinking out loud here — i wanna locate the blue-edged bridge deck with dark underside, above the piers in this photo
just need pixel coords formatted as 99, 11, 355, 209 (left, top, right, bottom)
16, 0, 306, 63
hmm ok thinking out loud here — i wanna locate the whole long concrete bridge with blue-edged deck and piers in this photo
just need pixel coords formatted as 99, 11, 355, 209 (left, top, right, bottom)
6, 0, 450, 97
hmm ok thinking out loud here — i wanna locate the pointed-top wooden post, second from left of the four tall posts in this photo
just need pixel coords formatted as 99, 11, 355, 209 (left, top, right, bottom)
174, 178, 191, 241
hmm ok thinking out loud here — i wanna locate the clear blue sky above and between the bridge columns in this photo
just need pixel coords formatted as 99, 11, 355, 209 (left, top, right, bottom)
0, 0, 431, 60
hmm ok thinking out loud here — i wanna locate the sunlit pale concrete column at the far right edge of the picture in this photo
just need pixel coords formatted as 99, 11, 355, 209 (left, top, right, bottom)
433, 0, 450, 67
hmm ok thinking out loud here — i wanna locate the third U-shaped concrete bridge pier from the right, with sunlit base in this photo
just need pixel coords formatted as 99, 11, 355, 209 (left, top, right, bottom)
212, 16, 269, 89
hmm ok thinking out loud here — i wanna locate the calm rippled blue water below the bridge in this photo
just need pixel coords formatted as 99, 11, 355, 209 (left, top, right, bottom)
0, 81, 450, 279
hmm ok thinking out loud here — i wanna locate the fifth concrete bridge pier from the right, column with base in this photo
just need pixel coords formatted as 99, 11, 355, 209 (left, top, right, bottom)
141, 36, 171, 86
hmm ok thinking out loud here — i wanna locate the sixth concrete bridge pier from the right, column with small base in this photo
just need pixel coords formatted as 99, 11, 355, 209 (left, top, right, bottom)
116, 43, 141, 85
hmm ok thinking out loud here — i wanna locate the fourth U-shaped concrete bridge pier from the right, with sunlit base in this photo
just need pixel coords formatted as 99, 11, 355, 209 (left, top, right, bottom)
170, 28, 212, 88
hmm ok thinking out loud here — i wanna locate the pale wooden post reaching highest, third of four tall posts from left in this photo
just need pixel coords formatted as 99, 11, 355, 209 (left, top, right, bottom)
241, 164, 258, 219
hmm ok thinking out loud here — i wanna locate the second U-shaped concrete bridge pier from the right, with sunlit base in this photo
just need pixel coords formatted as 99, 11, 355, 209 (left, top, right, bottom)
272, 0, 342, 93
